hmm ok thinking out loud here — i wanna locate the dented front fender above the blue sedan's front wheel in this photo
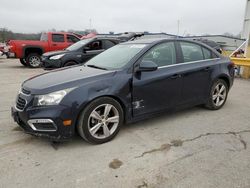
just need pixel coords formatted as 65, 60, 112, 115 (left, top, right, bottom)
62, 73, 132, 126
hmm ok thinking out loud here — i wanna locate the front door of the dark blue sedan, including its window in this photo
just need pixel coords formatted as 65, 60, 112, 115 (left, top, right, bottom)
132, 42, 182, 116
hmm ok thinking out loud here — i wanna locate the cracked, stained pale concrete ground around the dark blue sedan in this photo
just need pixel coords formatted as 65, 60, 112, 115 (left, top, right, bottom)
0, 59, 250, 188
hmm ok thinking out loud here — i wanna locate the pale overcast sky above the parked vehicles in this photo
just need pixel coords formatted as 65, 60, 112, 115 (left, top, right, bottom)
0, 0, 246, 35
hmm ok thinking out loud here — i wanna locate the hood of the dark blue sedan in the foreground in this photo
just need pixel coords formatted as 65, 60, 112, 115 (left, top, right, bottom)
22, 66, 116, 94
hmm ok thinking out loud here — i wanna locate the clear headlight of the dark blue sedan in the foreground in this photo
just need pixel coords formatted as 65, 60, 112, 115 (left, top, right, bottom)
34, 88, 74, 106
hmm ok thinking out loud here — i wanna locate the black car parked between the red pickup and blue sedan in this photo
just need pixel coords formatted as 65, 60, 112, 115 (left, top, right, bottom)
41, 37, 121, 69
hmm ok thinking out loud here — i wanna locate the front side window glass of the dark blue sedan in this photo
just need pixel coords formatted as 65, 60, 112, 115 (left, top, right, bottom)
143, 42, 176, 67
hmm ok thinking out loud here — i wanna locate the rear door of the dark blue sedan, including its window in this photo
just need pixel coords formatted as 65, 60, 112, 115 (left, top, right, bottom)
178, 41, 219, 104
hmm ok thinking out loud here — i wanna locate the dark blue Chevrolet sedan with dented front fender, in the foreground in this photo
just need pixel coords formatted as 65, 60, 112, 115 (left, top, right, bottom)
12, 39, 234, 144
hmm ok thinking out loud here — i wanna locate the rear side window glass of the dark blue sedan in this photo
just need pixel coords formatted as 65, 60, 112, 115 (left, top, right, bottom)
180, 42, 203, 62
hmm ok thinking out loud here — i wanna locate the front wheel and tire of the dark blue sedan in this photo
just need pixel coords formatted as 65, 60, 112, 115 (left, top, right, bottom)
77, 97, 124, 144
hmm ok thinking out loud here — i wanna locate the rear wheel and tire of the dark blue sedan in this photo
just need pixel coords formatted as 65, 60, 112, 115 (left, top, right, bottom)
205, 79, 229, 110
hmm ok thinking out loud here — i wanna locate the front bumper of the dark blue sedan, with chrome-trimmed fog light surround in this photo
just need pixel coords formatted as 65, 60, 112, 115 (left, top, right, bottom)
11, 105, 75, 140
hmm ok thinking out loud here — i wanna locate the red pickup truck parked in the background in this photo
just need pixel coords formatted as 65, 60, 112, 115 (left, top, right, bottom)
8, 32, 80, 68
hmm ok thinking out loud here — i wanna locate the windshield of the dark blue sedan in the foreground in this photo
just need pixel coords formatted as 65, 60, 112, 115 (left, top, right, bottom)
85, 44, 146, 70
